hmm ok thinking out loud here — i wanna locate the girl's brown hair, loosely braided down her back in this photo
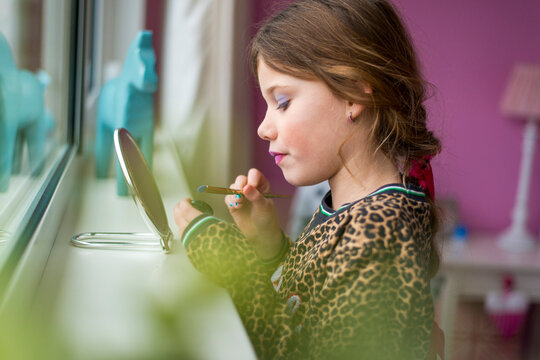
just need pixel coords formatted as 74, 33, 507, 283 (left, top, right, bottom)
250, 0, 441, 275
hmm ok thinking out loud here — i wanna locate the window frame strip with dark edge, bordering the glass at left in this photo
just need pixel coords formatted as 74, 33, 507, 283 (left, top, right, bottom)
0, 0, 86, 307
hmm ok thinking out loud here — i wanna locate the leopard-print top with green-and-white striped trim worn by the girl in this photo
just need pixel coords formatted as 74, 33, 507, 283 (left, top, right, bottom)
183, 184, 433, 360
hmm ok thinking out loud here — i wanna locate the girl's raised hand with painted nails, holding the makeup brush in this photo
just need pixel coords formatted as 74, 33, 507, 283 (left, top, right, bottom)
225, 169, 283, 259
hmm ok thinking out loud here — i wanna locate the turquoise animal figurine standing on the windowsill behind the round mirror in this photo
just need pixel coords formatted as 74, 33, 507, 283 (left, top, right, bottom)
95, 31, 158, 196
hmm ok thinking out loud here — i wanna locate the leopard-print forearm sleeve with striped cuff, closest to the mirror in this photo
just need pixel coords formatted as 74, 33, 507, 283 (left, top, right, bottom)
182, 215, 291, 356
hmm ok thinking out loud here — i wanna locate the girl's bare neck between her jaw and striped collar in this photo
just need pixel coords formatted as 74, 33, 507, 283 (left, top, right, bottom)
328, 152, 401, 210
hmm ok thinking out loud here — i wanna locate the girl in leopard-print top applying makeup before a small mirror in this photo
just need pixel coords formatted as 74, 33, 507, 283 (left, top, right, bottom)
174, 0, 440, 359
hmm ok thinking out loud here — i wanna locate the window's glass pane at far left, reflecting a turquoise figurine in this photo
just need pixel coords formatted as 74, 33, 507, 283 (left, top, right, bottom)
0, 0, 72, 267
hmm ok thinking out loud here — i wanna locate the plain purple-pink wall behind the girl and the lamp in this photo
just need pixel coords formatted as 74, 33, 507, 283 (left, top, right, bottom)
254, 0, 540, 238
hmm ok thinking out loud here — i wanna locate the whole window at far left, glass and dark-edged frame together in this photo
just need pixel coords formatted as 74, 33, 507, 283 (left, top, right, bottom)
0, 0, 85, 298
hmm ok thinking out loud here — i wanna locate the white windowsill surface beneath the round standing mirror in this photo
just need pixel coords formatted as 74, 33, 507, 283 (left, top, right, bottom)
38, 130, 255, 359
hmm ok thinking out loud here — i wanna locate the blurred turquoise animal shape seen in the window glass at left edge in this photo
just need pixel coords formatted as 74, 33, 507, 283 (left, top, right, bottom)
0, 33, 54, 192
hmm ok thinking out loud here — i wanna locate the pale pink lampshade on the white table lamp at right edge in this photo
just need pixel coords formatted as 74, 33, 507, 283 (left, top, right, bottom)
501, 64, 540, 121
